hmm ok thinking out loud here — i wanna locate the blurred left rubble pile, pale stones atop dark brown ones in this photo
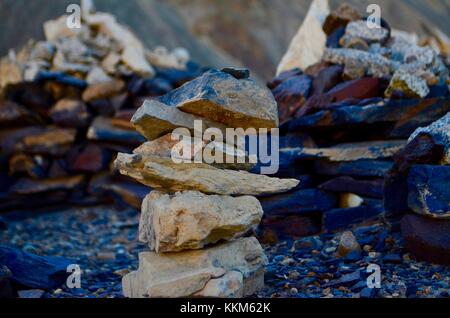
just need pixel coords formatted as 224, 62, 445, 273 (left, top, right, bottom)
0, 1, 202, 210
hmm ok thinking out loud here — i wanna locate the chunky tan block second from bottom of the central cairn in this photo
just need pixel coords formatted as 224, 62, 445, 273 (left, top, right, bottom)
139, 191, 263, 253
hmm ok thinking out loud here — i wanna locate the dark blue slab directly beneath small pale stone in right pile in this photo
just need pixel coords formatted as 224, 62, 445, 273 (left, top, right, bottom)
322, 206, 384, 232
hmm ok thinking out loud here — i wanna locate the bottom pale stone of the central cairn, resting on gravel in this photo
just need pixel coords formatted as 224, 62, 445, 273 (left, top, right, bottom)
122, 237, 267, 298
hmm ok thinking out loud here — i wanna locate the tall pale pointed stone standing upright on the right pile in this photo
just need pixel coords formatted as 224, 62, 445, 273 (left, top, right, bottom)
277, 0, 330, 75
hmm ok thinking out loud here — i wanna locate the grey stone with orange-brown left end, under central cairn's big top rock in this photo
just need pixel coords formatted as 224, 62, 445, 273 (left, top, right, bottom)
131, 100, 226, 141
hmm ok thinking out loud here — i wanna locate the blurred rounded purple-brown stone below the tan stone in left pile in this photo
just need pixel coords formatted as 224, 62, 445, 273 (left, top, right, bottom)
49, 99, 91, 128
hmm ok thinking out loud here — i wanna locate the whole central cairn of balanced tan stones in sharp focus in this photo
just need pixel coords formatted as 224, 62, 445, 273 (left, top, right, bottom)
115, 68, 299, 298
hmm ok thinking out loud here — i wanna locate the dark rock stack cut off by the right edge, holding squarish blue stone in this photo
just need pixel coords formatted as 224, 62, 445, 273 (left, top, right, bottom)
384, 113, 450, 265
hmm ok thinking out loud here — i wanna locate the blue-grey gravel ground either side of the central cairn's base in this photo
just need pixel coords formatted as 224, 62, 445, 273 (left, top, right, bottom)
0, 207, 450, 298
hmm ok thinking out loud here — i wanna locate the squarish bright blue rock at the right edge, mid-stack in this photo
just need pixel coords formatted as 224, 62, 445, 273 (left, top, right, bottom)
407, 165, 450, 219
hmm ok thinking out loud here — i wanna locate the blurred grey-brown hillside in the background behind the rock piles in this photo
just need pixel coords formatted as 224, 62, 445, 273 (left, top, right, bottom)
0, 0, 450, 81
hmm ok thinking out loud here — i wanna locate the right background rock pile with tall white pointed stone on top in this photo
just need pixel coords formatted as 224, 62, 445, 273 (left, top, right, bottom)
261, 0, 450, 240
